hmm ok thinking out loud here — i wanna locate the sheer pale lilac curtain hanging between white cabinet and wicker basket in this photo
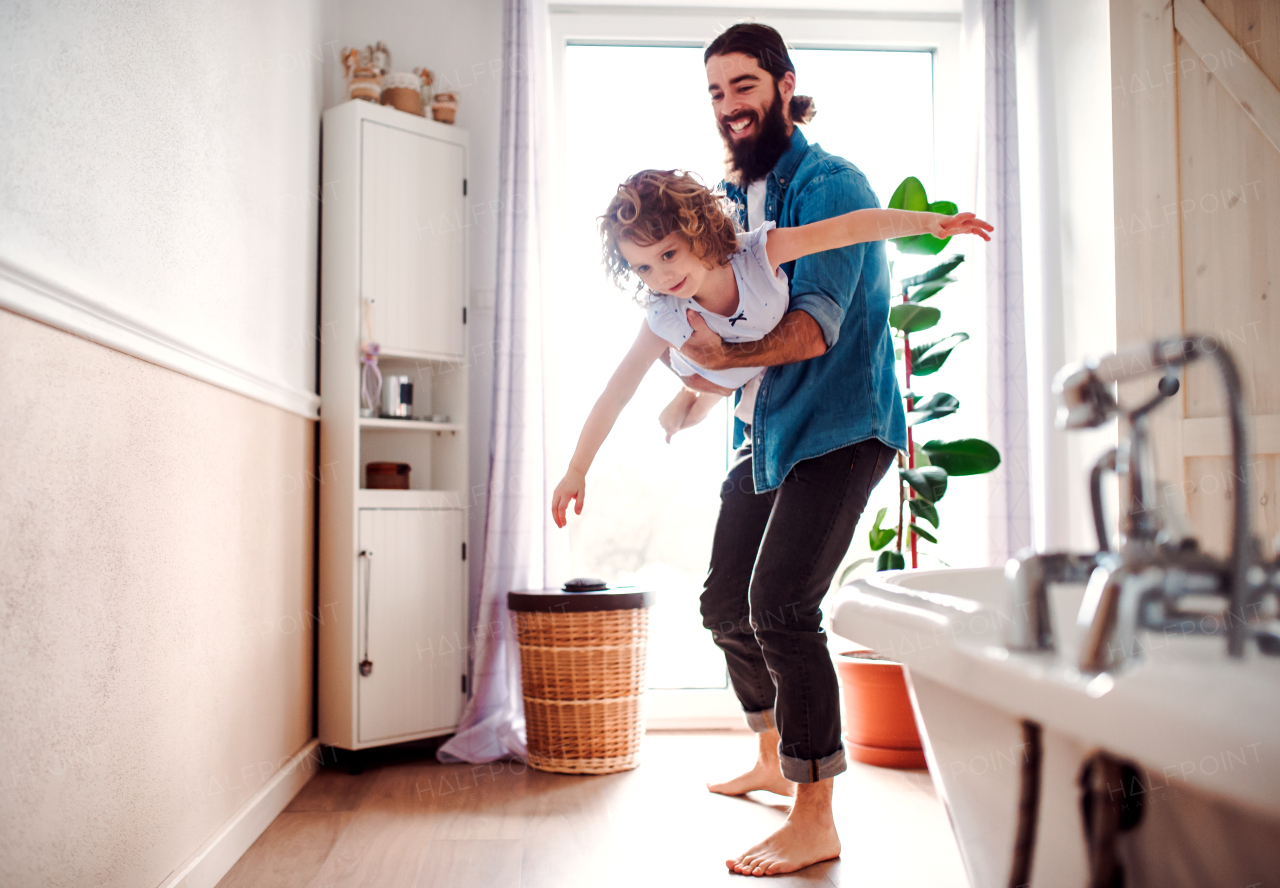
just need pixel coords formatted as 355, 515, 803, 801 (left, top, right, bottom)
439, 0, 564, 761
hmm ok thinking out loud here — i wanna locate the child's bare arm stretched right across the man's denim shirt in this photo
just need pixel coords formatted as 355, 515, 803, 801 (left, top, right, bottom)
767, 210, 993, 267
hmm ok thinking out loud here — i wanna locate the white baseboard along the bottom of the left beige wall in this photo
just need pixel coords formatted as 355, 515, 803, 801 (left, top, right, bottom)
160, 738, 320, 888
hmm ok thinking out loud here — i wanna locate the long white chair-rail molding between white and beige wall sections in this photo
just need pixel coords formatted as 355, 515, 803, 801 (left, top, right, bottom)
0, 258, 320, 420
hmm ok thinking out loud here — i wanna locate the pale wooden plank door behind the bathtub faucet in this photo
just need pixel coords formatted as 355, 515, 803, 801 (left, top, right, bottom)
1111, 0, 1280, 551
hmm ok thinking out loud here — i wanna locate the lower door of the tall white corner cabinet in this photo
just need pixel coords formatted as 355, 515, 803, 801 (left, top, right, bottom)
352, 509, 466, 743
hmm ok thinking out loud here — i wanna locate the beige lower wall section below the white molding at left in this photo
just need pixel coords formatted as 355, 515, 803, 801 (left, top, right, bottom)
0, 311, 315, 888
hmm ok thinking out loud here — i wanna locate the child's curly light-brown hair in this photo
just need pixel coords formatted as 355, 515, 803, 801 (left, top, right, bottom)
600, 170, 737, 301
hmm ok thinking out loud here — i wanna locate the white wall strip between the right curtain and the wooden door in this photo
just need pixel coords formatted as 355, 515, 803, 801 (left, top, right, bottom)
1016, 0, 1116, 550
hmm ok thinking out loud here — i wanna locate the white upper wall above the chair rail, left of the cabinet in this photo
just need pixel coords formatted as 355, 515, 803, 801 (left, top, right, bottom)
0, 0, 333, 409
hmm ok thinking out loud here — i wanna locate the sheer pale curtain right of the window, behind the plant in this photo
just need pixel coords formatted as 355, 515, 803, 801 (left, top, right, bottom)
964, 0, 1033, 564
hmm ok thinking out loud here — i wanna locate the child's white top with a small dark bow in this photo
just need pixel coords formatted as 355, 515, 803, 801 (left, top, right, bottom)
645, 223, 790, 424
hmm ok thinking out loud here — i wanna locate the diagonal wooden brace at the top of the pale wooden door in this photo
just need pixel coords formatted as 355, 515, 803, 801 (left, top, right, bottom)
1174, 0, 1280, 151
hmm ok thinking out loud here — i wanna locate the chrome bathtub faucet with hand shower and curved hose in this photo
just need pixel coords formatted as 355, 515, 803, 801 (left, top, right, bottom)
1005, 338, 1280, 672
